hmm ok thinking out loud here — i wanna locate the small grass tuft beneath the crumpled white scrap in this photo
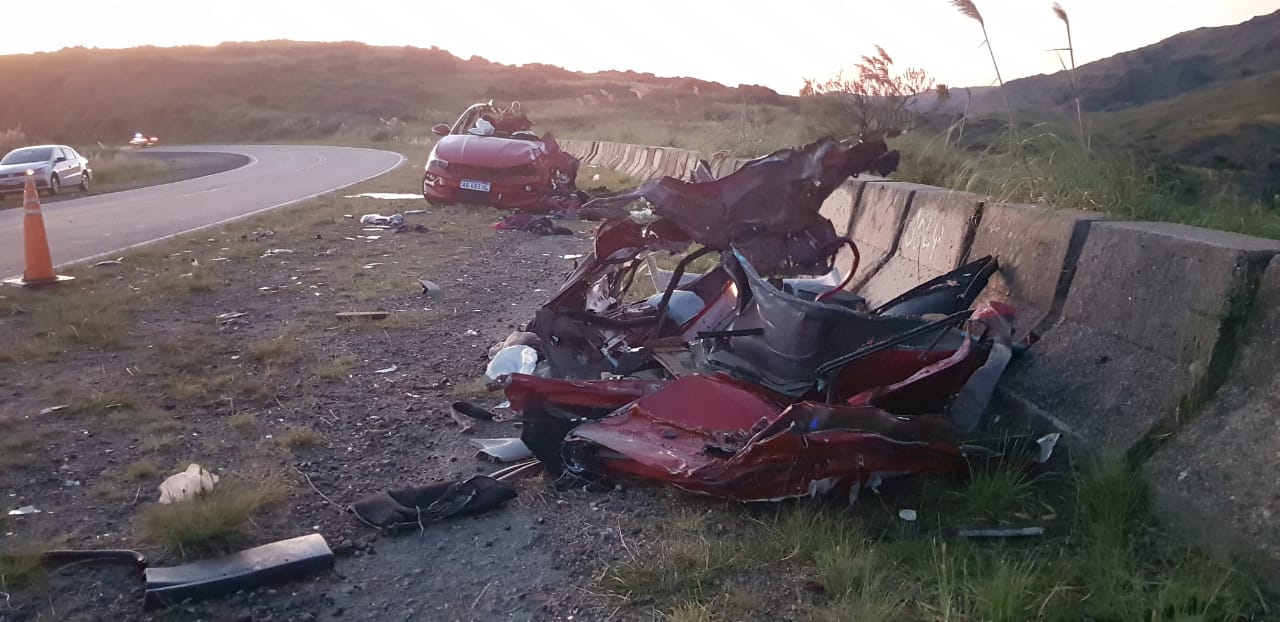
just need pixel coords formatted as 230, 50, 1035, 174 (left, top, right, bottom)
138, 475, 287, 557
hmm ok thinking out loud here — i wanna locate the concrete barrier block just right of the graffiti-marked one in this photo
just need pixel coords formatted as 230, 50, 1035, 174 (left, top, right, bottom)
965, 203, 1103, 334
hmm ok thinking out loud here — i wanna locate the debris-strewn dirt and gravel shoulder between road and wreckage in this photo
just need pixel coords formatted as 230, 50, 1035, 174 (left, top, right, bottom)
0, 158, 691, 621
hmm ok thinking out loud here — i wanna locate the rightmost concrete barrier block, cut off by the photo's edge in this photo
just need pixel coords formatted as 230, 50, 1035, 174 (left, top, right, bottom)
1146, 259, 1280, 575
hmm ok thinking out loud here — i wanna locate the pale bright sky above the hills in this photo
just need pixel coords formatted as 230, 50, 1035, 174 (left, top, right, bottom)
0, 0, 1280, 95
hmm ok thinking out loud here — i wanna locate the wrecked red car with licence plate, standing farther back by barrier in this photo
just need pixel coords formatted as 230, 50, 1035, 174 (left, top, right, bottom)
422, 102, 579, 211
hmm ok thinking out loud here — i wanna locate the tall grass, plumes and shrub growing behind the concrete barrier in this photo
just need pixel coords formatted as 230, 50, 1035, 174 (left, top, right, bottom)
803, 0, 1280, 238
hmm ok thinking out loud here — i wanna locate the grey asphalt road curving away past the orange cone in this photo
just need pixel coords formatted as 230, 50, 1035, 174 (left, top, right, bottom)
0, 145, 404, 276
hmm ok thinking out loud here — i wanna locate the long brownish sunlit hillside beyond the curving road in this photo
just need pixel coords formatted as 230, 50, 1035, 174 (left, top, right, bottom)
0, 41, 797, 153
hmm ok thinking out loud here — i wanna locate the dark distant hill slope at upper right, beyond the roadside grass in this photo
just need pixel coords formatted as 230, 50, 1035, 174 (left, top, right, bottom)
948, 10, 1280, 198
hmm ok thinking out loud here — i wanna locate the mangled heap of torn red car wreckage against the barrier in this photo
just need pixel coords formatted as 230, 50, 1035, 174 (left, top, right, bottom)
476, 138, 1052, 502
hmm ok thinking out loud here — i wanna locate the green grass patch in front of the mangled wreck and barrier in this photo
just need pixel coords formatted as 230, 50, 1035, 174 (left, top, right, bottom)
600, 461, 1268, 621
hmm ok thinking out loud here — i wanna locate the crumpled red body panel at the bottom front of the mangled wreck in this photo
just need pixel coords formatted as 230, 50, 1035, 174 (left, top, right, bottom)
566, 375, 965, 502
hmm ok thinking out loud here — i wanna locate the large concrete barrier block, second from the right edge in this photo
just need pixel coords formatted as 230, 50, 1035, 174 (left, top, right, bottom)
1005, 223, 1280, 452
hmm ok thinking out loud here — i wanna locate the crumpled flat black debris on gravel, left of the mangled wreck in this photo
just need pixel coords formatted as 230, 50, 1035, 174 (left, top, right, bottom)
351, 475, 516, 530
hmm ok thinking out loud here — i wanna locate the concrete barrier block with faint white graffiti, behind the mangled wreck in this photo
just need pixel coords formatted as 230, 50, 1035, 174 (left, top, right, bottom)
859, 184, 983, 306
